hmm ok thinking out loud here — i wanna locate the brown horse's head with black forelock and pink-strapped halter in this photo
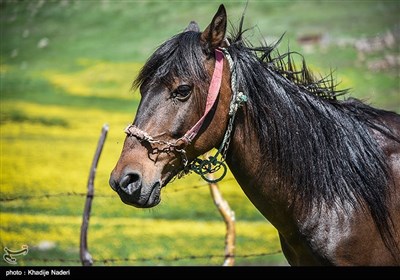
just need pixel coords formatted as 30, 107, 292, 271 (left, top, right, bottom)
109, 5, 231, 208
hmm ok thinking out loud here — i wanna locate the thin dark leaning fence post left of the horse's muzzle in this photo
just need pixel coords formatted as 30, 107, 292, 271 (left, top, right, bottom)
79, 124, 108, 266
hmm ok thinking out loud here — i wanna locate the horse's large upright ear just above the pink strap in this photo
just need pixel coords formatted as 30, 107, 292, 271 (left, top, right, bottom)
200, 4, 227, 53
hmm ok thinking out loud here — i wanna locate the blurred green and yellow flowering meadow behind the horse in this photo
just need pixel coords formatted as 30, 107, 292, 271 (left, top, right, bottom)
0, 0, 400, 266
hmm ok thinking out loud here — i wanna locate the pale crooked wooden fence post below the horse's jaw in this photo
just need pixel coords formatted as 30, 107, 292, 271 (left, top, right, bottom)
208, 174, 236, 266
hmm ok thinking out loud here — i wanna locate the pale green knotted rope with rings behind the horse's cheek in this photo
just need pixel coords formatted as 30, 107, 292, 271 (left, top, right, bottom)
185, 48, 247, 183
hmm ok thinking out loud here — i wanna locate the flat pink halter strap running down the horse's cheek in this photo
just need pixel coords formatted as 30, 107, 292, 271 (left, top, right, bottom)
180, 49, 224, 144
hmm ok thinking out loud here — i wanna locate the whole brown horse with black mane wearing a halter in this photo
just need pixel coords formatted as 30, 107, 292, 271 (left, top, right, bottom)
109, 5, 400, 266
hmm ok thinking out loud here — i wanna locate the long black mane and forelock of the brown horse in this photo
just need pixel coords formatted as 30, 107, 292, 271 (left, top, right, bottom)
133, 14, 400, 256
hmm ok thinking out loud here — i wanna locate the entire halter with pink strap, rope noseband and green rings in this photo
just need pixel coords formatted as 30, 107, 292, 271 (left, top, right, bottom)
125, 48, 247, 183
